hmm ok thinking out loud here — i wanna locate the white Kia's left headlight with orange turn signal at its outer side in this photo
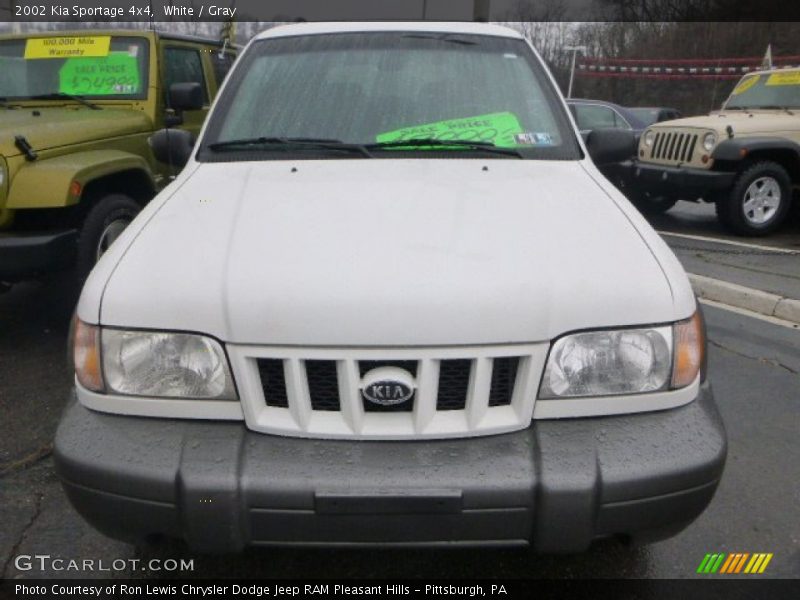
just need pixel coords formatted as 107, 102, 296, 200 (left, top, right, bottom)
74, 321, 237, 400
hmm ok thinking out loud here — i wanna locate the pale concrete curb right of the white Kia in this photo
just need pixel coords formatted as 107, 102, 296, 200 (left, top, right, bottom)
688, 273, 800, 323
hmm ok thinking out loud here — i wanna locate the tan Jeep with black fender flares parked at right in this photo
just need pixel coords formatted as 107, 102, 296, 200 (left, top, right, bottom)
631, 69, 800, 235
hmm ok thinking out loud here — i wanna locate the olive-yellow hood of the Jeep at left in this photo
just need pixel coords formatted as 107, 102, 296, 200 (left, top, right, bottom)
0, 107, 153, 156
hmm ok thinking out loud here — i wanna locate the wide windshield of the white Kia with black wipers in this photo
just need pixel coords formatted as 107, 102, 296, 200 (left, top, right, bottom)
198, 32, 580, 161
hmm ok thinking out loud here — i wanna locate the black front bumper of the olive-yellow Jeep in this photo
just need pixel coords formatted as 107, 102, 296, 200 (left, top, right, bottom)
0, 229, 78, 281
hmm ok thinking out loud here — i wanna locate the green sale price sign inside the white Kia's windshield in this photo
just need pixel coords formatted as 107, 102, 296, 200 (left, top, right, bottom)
375, 112, 523, 147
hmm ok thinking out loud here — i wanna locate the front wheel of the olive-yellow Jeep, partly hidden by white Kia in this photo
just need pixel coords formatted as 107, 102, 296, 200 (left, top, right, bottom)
78, 194, 141, 278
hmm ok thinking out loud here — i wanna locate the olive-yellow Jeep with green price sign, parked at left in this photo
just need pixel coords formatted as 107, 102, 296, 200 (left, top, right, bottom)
0, 30, 235, 289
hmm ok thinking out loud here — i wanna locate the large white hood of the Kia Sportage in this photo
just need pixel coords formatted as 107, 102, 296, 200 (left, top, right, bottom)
98, 159, 685, 346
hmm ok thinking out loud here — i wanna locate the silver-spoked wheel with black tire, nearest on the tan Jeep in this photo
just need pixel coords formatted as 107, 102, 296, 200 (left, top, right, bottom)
716, 161, 792, 236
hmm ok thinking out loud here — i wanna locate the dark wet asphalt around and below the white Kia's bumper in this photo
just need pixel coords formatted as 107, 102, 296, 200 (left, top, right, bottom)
0, 268, 800, 579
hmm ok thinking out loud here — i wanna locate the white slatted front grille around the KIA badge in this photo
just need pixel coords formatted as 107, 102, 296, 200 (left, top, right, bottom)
228, 344, 547, 439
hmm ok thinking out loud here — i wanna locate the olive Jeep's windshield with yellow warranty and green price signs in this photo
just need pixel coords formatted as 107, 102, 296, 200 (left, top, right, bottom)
0, 35, 148, 100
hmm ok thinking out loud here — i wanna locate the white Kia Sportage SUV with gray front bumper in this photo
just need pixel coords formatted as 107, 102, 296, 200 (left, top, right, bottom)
56, 23, 726, 552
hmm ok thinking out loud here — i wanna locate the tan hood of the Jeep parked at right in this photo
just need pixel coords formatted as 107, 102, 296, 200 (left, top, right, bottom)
651, 110, 800, 136
